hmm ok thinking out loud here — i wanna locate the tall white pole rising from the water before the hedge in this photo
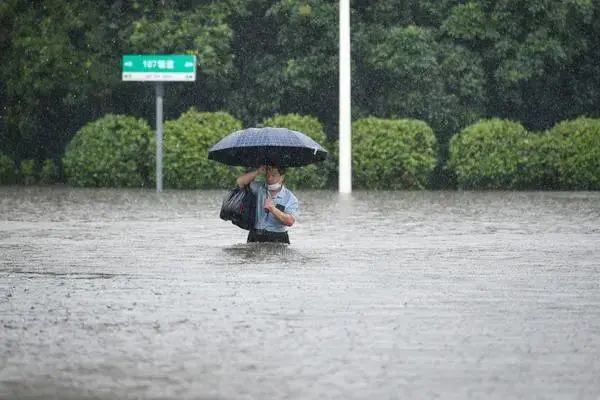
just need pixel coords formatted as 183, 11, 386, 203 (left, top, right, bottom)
339, 0, 352, 193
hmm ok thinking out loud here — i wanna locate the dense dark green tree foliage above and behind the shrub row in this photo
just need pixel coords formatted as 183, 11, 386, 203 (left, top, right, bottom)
0, 0, 600, 188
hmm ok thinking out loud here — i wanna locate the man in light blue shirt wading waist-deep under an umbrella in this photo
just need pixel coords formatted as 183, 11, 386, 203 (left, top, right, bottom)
237, 165, 298, 244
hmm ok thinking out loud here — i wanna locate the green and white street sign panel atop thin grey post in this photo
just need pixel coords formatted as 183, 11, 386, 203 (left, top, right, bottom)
122, 54, 196, 82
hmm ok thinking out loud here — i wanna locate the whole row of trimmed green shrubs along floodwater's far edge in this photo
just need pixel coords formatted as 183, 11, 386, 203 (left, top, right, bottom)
59, 108, 600, 190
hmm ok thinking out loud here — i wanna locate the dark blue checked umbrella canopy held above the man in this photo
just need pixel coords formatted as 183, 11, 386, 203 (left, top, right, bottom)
208, 127, 327, 168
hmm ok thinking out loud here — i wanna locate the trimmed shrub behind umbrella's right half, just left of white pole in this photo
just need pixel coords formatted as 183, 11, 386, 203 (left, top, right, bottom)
263, 114, 331, 189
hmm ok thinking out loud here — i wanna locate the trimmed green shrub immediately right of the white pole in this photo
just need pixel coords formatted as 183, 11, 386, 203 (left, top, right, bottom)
352, 117, 437, 190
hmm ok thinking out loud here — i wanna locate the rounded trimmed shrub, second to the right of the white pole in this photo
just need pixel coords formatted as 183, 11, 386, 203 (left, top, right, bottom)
447, 119, 541, 189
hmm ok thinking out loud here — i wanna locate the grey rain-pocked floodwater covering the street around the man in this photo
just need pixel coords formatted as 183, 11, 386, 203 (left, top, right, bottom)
0, 187, 600, 399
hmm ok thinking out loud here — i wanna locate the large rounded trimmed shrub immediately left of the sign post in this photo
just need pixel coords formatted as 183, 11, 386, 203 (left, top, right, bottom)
63, 114, 152, 187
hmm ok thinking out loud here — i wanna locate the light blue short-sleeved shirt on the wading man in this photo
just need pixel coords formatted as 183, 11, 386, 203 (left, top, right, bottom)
250, 181, 298, 232
